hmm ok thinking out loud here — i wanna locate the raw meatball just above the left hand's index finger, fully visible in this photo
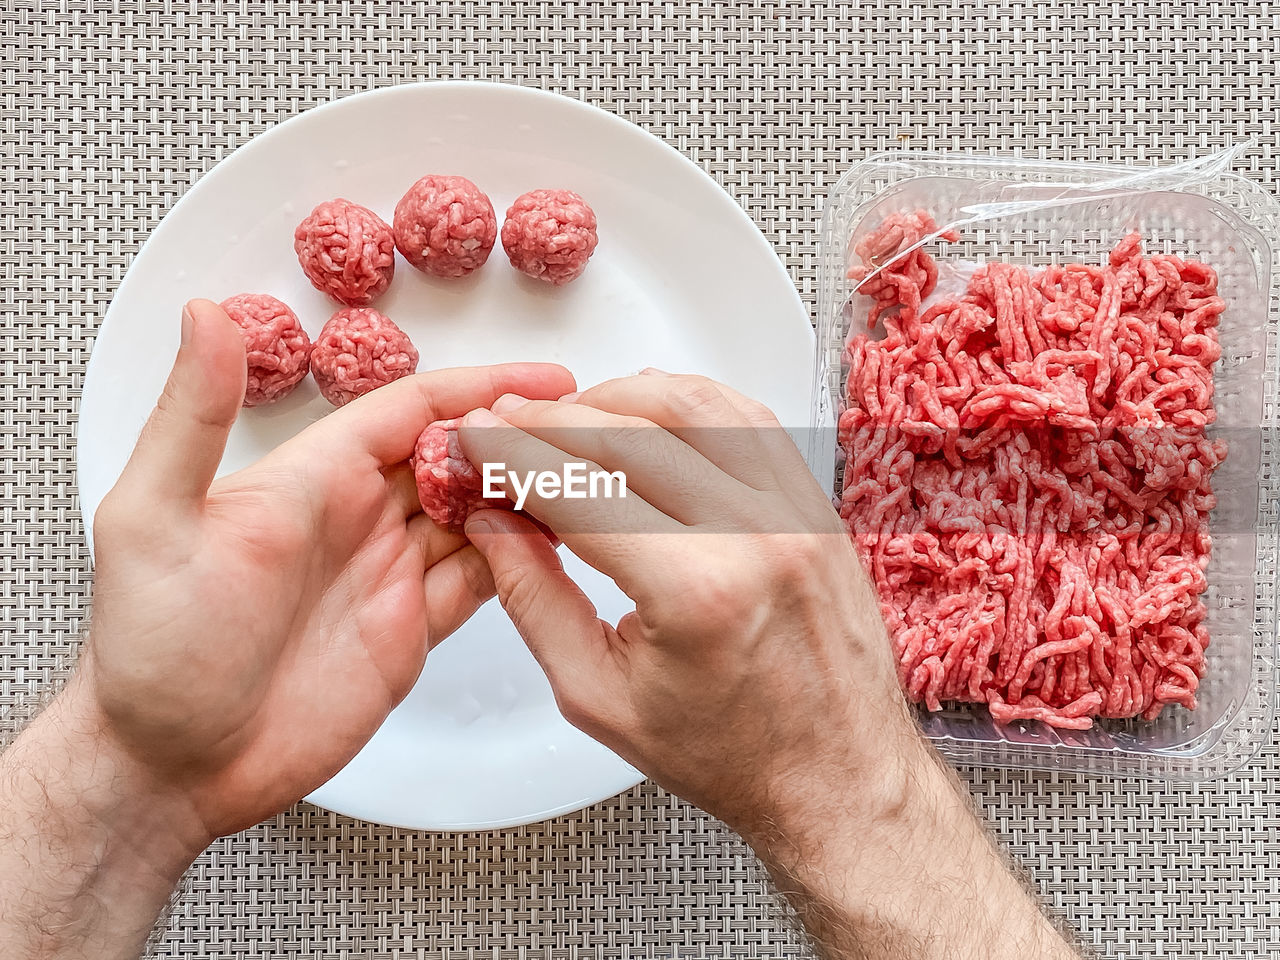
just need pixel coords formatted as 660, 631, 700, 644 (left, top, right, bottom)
311, 307, 417, 407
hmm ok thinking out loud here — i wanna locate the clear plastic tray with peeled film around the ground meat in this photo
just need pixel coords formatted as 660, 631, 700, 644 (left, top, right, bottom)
808, 152, 1280, 780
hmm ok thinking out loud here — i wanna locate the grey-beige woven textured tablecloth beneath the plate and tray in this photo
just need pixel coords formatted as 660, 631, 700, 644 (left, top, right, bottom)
0, 0, 1280, 960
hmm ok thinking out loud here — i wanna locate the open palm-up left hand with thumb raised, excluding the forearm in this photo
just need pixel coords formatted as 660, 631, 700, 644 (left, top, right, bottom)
64, 301, 573, 844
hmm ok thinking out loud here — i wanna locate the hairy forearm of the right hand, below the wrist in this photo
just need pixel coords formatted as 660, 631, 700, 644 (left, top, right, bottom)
749, 742, 1079, 960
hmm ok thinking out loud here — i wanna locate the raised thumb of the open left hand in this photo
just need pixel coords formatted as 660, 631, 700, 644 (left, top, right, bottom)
120, 300, 248, 504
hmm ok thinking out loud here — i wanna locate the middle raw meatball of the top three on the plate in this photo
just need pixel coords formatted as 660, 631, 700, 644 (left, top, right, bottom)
394, 175, 498, 276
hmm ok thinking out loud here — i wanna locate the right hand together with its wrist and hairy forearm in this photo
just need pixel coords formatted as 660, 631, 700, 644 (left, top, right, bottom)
461, 371, 1075, 960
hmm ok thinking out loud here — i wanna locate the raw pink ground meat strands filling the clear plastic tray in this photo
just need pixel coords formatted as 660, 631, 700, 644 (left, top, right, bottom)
840, 211, 1226, 730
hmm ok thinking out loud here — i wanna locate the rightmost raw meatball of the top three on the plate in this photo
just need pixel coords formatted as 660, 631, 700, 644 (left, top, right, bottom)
502, 189, 598, 287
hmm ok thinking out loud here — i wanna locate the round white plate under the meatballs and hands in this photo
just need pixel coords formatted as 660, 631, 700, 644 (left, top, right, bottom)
77, 82, 813, 829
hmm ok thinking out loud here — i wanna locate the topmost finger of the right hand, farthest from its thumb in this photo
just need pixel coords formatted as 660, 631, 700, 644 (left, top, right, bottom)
573, 374, 780, 490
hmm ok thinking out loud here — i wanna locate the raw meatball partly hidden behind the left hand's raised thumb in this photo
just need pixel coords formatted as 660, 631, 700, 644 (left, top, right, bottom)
221, 293, 311, 407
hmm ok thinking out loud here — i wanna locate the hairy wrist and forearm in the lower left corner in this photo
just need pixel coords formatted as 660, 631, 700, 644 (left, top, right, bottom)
0, 680, 206, 960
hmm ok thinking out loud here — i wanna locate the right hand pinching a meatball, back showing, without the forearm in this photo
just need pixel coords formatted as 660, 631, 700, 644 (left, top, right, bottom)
461, 371, 922, 845
